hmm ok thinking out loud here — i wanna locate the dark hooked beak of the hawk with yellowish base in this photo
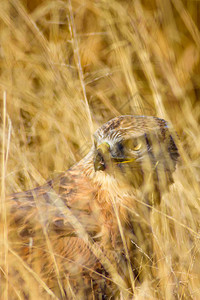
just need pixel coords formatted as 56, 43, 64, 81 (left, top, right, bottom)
94, 142, 110, 172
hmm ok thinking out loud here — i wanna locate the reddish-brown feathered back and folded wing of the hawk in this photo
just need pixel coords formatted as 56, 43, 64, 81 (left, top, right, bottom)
7, 165, 116, 299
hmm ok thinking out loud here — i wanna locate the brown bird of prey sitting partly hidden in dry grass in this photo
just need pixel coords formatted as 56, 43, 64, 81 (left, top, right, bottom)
3, 115, 179, 300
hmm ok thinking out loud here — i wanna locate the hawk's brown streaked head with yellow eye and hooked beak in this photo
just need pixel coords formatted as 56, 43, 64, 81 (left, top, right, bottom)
94, 116, 179, 197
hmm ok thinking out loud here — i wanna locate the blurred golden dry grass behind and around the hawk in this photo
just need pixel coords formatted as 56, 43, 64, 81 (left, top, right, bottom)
0, 0, 200, 299
